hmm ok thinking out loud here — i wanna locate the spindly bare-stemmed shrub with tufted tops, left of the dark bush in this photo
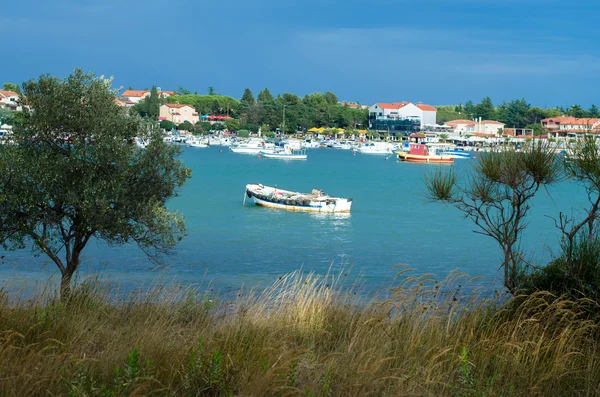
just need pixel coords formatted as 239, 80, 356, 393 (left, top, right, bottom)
426, 142, 562, 293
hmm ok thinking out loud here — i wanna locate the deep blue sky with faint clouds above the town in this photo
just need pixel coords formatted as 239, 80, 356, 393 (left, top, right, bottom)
0, 0, 600, 108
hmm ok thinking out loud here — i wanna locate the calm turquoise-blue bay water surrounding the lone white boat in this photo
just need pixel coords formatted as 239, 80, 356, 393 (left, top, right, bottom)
0, 147, 585, 289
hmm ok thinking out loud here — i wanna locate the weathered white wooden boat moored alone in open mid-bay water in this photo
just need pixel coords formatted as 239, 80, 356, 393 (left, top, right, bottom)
244, 184, 352, 212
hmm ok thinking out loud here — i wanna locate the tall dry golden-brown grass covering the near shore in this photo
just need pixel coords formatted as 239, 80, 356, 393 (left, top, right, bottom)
0, 273, 600, 396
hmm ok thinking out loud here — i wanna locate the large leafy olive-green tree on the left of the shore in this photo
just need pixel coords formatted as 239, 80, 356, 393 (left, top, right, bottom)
0, 69, 190, 299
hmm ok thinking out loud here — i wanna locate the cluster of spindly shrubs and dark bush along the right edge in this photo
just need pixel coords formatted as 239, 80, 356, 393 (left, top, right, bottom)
426, 137, 600, 322
